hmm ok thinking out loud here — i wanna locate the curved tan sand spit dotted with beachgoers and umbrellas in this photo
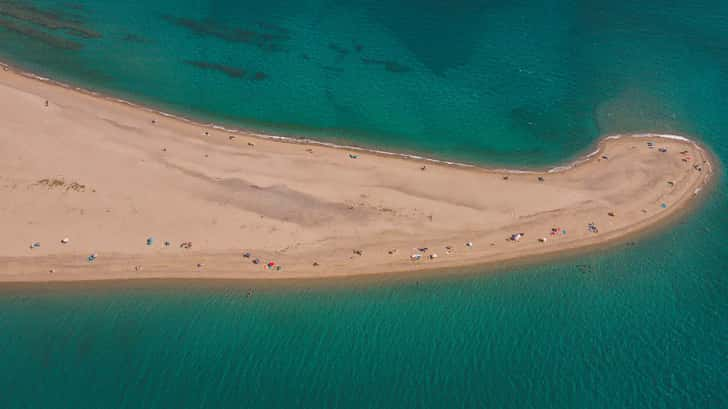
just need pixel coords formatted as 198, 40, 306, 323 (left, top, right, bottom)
0, 65, 714, 282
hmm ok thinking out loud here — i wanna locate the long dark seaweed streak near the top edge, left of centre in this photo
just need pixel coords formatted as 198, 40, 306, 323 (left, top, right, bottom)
162, 15, 290, 52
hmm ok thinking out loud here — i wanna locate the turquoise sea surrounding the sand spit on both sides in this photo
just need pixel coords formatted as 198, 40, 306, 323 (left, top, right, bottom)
0, 0, 728, 409
